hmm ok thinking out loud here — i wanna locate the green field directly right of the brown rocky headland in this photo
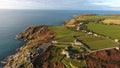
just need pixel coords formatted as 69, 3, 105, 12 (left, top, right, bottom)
49, 26, 79, 42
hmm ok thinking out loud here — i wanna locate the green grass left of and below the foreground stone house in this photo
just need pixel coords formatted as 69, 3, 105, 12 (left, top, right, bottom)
49, 45, 86, 68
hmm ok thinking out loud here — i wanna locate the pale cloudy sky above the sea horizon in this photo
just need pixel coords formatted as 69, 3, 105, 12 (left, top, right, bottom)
0, 0, 120, 10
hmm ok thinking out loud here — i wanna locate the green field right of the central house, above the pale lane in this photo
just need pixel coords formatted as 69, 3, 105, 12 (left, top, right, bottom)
77, 35, 116, 49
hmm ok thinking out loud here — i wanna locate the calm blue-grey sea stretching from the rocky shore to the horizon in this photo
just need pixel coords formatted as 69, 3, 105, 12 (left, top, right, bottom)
0, 10, 120, 63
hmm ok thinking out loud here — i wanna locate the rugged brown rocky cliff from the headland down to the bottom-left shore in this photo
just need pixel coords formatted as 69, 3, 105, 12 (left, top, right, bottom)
4, 26, 55, 68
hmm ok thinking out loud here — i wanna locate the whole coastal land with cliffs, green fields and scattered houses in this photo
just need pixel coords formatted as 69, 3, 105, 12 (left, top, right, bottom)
4, 14, 120, 68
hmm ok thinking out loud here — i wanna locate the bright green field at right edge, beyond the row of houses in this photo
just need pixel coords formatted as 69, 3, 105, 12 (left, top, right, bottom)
87, 23, 120, 39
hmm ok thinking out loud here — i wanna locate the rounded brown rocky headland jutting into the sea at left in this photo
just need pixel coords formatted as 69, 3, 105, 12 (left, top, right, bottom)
17, 26, 55, 41
